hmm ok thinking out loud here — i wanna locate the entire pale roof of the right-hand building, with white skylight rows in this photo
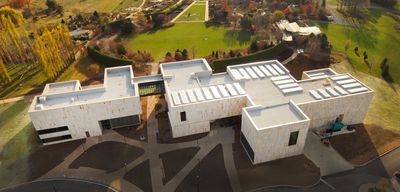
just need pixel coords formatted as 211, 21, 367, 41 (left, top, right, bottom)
161, 59, 372, 128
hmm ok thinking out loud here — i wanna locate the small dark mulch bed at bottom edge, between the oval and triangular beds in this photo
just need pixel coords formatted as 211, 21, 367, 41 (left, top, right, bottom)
124, 160, 153, 192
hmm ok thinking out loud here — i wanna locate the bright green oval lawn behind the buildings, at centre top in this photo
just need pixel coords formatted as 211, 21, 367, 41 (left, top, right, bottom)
123, 23, 254, 61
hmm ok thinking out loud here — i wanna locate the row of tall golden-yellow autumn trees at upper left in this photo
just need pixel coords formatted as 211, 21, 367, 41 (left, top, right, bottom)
0, 8, 75, 84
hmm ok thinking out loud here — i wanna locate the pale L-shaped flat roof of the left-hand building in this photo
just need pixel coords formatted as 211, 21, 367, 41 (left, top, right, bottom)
30, 66, 137, 111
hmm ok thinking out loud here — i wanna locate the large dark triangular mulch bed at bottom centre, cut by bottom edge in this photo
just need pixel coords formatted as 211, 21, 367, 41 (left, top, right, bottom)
175, 144, 232, 192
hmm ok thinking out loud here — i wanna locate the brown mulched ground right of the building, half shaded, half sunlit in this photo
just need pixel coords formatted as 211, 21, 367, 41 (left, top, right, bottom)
330, 124, 400, 178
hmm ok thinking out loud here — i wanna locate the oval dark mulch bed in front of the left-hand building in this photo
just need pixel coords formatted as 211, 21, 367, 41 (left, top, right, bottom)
69, 141, 144, 173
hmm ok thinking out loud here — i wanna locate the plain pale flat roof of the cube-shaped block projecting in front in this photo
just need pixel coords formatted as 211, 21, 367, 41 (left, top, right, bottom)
246, 103, 308, 129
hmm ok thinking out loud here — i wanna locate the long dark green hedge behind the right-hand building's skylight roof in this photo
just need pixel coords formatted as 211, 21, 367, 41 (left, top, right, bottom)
212, 42, 288, 73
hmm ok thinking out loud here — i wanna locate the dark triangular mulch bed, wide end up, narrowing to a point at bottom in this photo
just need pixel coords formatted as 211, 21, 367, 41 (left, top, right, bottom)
160, 147, 200, 185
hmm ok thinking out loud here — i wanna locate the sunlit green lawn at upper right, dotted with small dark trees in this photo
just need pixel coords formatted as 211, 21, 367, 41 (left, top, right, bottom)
320, 10, 400, 84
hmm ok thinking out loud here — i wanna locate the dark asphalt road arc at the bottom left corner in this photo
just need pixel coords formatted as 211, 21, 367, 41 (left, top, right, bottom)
0, 179, 116, 192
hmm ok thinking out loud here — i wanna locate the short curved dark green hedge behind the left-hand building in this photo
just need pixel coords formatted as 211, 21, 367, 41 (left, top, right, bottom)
87, 47, 133, 67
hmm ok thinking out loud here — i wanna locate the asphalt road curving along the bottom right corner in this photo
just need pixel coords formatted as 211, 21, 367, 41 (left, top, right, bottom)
259, 148, 400, 192
